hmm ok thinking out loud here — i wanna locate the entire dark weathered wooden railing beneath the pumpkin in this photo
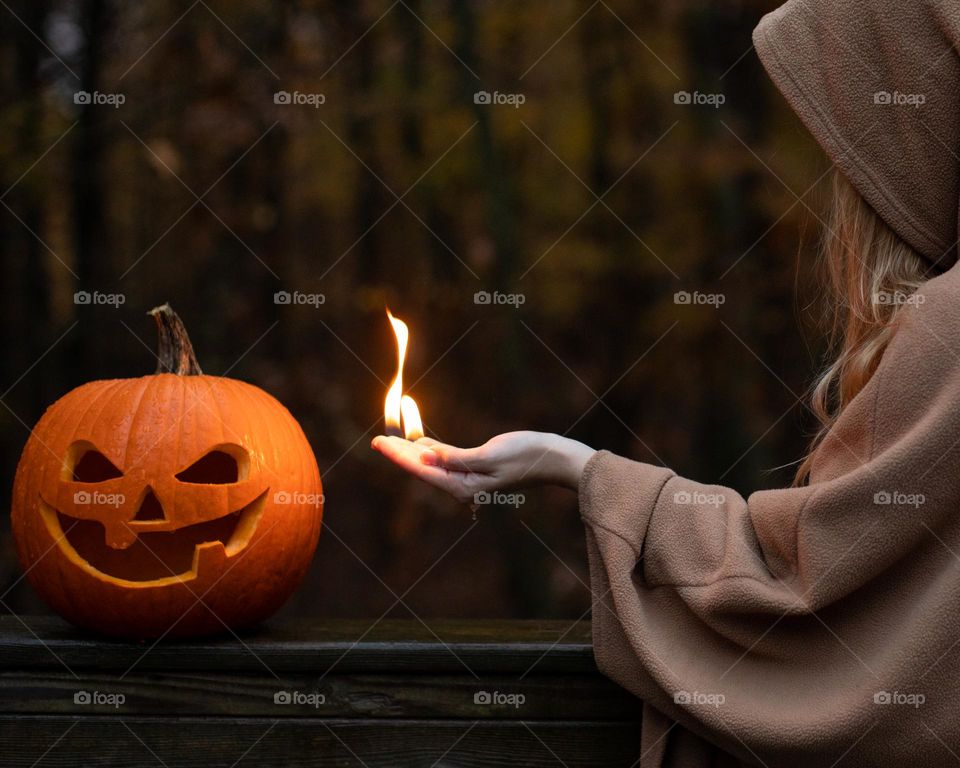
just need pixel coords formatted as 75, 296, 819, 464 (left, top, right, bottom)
0, 616, 640, 768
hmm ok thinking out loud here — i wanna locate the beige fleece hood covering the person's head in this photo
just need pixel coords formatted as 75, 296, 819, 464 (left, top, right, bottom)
753, 0, 960, 268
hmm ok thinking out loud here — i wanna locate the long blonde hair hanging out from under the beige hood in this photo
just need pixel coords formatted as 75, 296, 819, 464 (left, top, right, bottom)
794, 171, 930, 485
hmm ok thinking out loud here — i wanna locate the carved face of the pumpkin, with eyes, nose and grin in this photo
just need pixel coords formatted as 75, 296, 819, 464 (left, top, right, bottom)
40, 440, 269, 582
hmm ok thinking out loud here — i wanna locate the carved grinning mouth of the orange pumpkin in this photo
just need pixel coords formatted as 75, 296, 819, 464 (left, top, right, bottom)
40, 491, 267, 582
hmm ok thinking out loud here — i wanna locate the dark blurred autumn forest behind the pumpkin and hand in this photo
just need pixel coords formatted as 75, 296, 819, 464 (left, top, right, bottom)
0, 0, 829, 618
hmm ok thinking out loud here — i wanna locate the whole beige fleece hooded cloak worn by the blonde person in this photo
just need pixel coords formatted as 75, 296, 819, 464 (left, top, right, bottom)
579, 0, 960, 768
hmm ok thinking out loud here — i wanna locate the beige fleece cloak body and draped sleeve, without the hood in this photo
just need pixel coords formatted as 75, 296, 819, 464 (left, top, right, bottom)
580, 258, 960, 768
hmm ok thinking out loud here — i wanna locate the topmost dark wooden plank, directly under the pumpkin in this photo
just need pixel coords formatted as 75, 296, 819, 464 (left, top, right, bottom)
0, 616, 596, 675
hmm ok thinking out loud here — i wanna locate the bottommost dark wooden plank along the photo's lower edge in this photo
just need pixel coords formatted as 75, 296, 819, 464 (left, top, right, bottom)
0, 716, 640, 768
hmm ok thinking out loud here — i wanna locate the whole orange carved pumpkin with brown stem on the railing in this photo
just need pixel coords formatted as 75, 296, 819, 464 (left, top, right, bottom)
12, 305, 323, 639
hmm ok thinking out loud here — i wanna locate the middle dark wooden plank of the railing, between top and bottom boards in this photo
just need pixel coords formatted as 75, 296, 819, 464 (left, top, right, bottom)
0, 670, 641, 722
